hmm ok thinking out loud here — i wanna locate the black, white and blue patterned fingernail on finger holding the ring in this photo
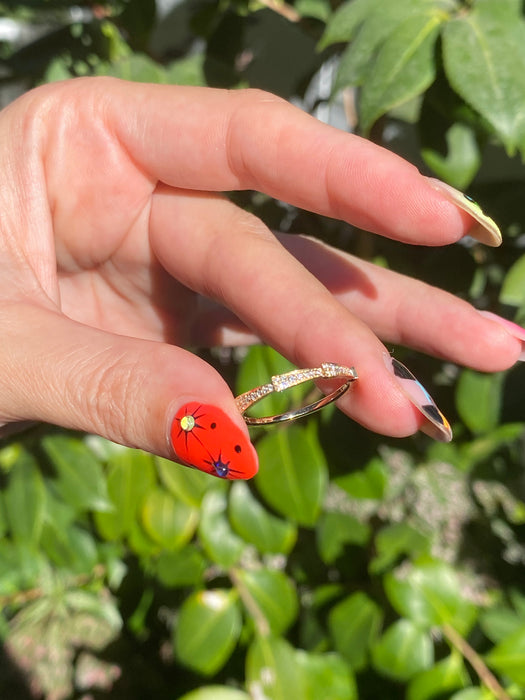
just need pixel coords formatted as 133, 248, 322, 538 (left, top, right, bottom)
383, 353, 452, 442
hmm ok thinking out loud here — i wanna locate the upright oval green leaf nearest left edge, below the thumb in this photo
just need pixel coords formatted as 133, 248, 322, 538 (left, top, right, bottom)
4, 449, 46, 546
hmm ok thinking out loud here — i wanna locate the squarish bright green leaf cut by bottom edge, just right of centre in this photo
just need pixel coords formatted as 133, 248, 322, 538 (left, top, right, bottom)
295, 649, 357, 700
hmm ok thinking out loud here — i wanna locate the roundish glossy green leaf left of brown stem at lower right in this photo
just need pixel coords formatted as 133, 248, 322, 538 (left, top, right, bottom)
372, 620, 434, 681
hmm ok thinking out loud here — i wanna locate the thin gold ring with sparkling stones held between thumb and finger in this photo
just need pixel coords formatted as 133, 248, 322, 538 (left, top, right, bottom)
235, 362, 357, 425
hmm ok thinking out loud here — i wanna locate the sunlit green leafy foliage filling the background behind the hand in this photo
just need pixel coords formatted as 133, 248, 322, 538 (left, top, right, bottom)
0, 0, 525, 700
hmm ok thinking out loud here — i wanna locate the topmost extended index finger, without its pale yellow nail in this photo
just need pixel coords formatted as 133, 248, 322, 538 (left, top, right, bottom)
90, 81, 473, 245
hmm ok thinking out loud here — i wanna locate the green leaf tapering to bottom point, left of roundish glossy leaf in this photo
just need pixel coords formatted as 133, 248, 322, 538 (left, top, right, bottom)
328, 593, 383, 671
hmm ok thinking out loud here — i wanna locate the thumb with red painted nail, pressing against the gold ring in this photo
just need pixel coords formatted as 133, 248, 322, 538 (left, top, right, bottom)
0, 305, 257, 479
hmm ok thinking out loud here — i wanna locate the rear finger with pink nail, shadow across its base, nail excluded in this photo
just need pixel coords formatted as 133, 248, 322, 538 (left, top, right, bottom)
279, 234, 521, 372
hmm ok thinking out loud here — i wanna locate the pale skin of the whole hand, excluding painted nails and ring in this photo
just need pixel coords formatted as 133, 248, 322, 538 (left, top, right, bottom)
0, 79, 521, 457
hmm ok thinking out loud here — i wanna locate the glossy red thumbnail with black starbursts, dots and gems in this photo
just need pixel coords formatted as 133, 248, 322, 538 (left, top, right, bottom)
170, 401, 258, 479
